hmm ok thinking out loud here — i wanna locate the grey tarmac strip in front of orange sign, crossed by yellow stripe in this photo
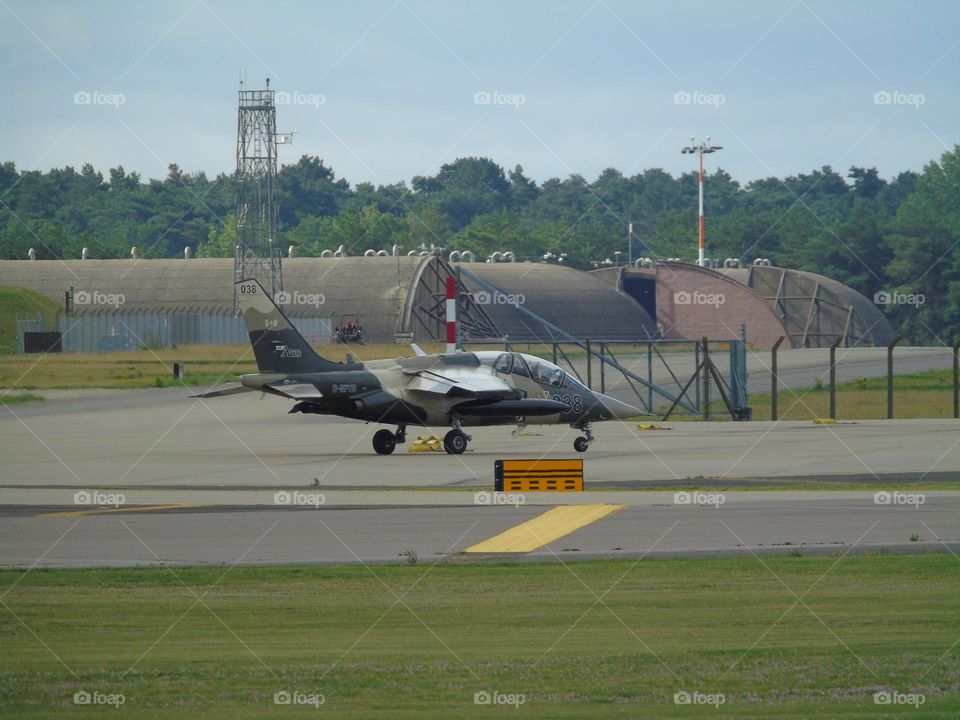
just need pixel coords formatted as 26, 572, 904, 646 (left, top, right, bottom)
0, 491, 960, 567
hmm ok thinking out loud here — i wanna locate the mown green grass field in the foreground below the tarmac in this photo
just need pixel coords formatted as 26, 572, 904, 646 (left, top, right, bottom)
0, 554, 960, 718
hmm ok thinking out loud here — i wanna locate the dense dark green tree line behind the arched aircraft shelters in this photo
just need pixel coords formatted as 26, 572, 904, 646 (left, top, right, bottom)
0, 146, 960, 344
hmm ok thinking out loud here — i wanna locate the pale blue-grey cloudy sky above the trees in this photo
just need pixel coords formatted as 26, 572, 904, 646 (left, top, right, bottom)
0, 0, 960, 184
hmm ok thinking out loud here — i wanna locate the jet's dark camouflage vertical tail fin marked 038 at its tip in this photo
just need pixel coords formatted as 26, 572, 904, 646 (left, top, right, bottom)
237, 279, 349, 374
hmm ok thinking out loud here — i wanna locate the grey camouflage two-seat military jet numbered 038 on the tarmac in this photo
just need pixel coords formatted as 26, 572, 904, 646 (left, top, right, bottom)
194, 280, 642, 455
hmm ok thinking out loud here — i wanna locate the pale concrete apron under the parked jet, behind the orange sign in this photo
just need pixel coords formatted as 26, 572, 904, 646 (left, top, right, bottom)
0, 388, 960, 490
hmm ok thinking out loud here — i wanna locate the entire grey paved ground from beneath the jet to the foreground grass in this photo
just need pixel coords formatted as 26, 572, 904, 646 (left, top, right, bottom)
0, 388, 960, 567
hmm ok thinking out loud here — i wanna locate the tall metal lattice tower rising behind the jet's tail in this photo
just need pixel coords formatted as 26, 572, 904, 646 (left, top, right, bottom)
233, 78, 293, 310
